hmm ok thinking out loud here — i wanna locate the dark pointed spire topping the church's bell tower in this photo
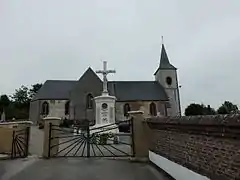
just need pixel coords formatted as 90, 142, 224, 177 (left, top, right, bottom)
154, 43, 177, 75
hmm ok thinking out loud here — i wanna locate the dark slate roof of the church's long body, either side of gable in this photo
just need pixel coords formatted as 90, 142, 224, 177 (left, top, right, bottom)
33, 80, 168, 101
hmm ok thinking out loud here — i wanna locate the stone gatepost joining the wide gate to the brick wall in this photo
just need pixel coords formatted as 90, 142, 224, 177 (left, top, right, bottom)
128, 111, 150, 159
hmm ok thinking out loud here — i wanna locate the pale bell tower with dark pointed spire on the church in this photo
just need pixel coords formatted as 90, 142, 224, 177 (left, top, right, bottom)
154, 44, 181, 116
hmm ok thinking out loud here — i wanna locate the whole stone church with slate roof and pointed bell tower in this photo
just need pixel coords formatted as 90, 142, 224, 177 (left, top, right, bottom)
29, 44, 181, 123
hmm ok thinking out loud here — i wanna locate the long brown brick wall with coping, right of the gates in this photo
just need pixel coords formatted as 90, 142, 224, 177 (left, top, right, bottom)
147, 115, 240, 180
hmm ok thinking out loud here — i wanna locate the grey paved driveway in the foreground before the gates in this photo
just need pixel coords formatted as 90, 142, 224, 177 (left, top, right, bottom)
0, 158, 172, 180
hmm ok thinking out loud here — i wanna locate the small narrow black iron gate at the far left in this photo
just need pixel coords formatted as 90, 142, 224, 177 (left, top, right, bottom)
11, 127, 30, 159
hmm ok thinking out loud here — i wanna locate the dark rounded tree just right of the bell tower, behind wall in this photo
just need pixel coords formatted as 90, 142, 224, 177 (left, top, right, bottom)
185, 103, 215, 116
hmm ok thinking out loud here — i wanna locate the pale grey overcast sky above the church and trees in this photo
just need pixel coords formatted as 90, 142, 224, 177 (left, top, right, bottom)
0, 0, 240, 111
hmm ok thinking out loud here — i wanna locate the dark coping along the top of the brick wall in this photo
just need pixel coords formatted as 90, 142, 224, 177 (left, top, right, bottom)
146, 114, 240, 139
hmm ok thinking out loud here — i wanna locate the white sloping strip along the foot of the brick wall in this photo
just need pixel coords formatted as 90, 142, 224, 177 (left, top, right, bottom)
149, 151, 210, 180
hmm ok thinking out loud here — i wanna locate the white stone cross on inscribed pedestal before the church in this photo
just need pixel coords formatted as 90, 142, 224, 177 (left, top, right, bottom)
94, 61, 116, 127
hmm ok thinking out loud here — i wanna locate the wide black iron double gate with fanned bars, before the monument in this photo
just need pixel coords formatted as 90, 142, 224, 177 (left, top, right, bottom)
48, 120, 134, 158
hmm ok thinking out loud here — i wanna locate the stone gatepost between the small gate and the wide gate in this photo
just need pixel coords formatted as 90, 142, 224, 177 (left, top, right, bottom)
43, 117, 61, 158
